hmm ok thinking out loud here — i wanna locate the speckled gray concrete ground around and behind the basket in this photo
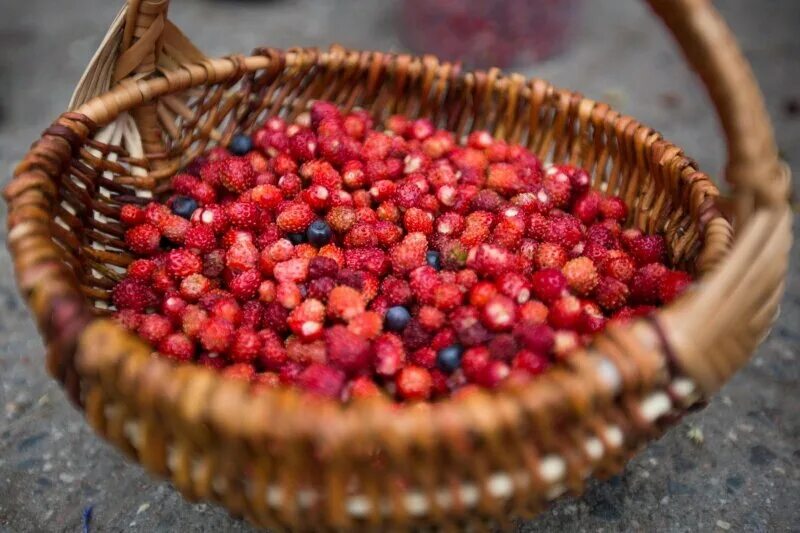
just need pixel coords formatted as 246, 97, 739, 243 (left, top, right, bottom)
0, 0, 800, 531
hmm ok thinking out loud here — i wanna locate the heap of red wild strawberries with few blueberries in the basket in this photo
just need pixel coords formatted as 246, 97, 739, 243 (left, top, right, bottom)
113, 102, 691, 401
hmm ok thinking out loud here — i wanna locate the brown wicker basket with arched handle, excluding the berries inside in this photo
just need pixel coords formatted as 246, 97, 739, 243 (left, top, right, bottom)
5, 0, 791, 529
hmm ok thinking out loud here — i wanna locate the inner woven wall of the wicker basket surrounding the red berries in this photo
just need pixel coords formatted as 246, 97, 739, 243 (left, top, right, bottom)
53, 50, 717, 312
